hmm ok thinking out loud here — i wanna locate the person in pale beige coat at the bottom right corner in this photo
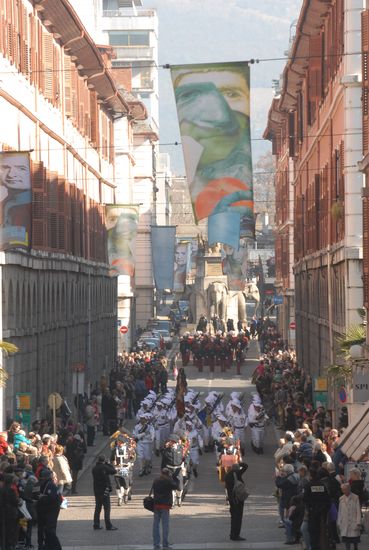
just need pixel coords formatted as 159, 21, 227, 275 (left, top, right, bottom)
337, 483, 361, 550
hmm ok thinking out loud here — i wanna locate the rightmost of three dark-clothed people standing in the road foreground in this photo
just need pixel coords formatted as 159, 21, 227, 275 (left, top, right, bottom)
225, 462, 248, 541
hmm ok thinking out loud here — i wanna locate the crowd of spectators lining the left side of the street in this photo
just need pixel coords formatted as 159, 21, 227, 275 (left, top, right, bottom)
0, 351, 168, 550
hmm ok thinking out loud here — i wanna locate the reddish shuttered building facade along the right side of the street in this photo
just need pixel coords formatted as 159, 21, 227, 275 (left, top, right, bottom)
269, 0, 364, 388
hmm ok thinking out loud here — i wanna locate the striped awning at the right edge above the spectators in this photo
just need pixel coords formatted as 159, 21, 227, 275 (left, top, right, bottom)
340, 402, 369, 461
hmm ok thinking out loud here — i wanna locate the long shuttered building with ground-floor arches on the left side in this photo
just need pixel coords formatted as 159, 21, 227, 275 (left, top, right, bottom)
0, 0, 129, 424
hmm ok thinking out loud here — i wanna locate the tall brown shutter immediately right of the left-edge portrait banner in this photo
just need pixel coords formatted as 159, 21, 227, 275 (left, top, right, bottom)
32, 162, 46, 248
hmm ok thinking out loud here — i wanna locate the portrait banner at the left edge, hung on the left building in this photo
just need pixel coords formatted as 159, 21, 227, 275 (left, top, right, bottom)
0, 151, 32, 250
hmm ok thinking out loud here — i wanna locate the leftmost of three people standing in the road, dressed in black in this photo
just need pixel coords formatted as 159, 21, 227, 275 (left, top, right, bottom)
92, 455, 117, 531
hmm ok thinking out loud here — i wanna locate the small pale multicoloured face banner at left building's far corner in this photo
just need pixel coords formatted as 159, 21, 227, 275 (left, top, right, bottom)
105, 204, 139, 277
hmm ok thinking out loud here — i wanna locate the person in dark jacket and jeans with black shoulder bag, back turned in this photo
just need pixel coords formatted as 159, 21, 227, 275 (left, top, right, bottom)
152, 468, 178, 550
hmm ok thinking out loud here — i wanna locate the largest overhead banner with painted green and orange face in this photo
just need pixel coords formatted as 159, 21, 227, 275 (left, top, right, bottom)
171, 62, 254, 240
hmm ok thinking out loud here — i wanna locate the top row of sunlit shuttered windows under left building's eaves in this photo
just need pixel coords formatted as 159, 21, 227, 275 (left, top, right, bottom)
0, 0, 114, 162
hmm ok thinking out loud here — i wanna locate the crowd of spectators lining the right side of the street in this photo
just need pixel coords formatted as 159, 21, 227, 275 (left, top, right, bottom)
253, 327, 369, 550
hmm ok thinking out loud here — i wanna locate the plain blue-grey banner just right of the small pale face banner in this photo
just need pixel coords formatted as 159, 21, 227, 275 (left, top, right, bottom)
151, 225, 176, 290
